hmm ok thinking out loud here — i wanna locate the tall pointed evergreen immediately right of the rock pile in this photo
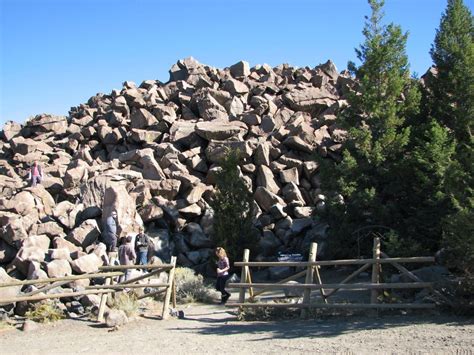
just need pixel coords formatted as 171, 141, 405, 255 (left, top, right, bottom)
321, 0, 419, 258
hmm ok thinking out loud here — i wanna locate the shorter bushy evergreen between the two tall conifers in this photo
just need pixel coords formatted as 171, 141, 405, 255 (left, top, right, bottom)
394, 120, 455, 253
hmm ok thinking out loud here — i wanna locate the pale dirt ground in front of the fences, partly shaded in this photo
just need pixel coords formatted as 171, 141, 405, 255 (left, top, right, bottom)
0, 305, 474, 354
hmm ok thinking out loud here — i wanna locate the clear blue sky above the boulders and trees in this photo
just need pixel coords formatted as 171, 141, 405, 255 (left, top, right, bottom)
0, 0, 474, 127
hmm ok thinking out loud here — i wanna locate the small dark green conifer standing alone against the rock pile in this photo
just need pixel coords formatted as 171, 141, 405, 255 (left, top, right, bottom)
210, 150, 256, 262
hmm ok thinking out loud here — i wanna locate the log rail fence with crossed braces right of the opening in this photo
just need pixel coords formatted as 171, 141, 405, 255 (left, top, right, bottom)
228, 238, 435, 317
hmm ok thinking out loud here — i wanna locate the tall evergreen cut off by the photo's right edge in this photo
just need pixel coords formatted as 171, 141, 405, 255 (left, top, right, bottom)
426, 0, 474, 273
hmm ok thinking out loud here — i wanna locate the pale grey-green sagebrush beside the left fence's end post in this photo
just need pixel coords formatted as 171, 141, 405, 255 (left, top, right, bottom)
175, 267, 212, 304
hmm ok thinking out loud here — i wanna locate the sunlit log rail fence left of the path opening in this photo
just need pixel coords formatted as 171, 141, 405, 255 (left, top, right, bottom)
0, 256, 176, 322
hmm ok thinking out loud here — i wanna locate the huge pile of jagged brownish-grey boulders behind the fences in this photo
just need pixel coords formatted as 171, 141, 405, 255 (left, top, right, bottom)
0, 58, 354, 286
